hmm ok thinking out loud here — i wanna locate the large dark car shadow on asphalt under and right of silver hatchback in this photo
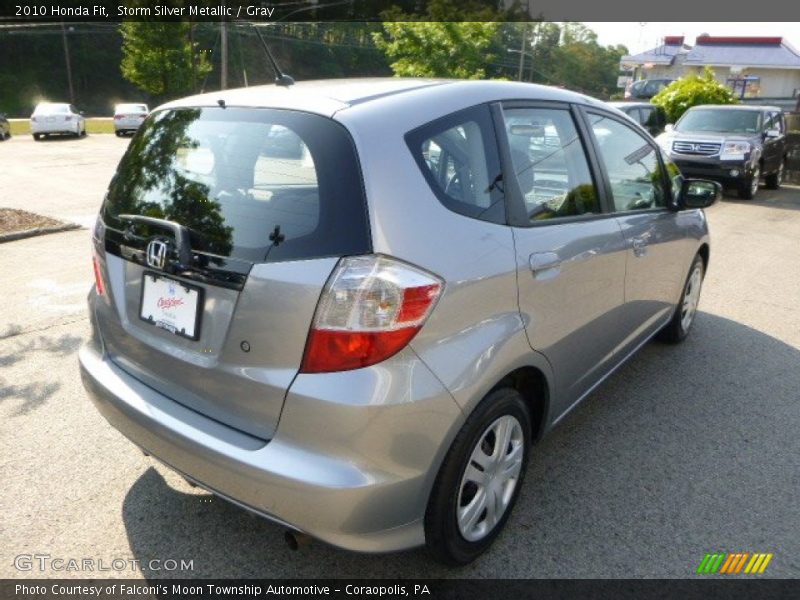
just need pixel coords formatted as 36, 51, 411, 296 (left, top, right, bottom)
122, 313, 800, 578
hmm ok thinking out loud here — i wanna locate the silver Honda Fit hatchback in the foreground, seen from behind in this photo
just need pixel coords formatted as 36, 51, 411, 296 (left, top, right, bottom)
80, 79, 719, 564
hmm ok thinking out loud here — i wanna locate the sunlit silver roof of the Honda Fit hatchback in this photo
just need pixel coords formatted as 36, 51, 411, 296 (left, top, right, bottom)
157, 77, 603, 117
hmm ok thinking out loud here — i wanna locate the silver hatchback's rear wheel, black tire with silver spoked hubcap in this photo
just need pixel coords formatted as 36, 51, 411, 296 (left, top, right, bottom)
425, 388, 531, 565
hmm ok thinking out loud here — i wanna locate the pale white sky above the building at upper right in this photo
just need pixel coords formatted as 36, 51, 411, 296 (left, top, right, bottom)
584, 22, 800, 54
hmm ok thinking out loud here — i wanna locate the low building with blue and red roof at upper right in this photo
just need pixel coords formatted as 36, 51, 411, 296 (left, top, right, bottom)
620, 35, 800, 98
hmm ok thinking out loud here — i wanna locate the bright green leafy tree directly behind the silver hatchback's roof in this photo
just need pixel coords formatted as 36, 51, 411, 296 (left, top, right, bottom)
373, 22, 499, 79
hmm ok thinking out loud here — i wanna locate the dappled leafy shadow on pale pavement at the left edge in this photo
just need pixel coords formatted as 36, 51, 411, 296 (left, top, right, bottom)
0, 325, 82, 416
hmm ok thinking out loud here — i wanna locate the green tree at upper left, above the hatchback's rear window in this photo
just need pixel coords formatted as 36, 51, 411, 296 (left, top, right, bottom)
121, 21, 211, 98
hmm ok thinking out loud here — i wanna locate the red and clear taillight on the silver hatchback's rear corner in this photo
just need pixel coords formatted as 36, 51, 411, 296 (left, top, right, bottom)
300, 256, 443, 373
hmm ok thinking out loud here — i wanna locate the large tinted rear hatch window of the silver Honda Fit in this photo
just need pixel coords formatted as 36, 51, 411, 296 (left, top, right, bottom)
102, 107, 370, 263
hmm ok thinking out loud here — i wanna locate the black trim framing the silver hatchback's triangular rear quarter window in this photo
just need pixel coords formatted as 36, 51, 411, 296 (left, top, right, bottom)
403, 102, 509, 225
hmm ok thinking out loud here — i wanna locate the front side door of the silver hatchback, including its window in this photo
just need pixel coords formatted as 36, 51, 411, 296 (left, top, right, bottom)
584, 110, 689, 348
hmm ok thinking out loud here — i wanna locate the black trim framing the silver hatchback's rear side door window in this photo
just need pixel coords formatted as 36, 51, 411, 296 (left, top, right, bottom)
491, 100, 613, 229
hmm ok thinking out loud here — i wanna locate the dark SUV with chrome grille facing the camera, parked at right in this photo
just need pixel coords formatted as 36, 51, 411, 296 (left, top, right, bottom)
658, 104, 788, 199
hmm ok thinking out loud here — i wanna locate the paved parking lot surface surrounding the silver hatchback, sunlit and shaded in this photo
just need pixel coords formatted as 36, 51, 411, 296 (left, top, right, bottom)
0, 135, 800, 578
